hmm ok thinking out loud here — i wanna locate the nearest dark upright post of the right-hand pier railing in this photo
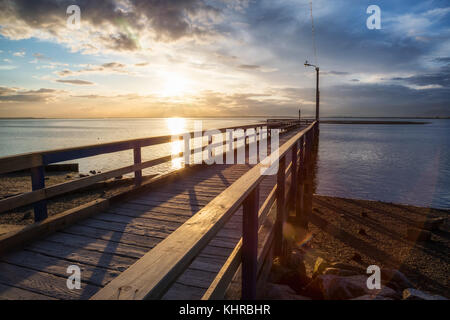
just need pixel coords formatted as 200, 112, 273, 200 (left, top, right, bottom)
242, 186, 259, 300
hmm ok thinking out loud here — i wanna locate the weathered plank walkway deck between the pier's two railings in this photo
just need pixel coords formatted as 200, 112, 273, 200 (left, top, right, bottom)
0, 130, 298, 300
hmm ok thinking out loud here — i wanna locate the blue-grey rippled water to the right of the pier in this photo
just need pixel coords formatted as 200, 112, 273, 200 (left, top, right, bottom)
317, 119, 450, 209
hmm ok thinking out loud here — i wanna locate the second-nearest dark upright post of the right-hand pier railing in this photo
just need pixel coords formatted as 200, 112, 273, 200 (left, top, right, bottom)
274, 156, 286, 256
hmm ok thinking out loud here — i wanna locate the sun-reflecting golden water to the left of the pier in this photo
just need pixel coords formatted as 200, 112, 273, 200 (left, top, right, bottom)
0, 118, 263, 176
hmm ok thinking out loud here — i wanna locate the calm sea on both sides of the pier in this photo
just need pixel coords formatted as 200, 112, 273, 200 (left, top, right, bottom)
0, 119, 450, 208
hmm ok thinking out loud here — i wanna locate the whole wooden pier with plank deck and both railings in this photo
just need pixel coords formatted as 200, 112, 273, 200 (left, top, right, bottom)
0, 120, 319, 300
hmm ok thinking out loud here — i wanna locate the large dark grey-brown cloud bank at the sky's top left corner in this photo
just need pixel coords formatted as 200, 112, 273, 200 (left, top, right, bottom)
0, 0, 220, 53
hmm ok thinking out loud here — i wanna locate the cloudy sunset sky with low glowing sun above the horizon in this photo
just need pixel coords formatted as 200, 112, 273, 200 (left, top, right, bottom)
0, 0, 450, 118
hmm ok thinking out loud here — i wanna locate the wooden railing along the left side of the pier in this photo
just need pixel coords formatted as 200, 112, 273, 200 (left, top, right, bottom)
0, 123, 288, 221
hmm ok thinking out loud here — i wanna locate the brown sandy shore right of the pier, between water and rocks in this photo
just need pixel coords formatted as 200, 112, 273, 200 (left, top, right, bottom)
296, 196, 450, 298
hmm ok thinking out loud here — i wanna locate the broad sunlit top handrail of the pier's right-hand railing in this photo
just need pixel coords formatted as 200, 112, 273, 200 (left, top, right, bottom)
92, 121, 317, 300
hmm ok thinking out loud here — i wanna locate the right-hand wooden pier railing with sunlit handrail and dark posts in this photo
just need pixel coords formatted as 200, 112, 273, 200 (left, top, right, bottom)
93, 122, 318, 300
